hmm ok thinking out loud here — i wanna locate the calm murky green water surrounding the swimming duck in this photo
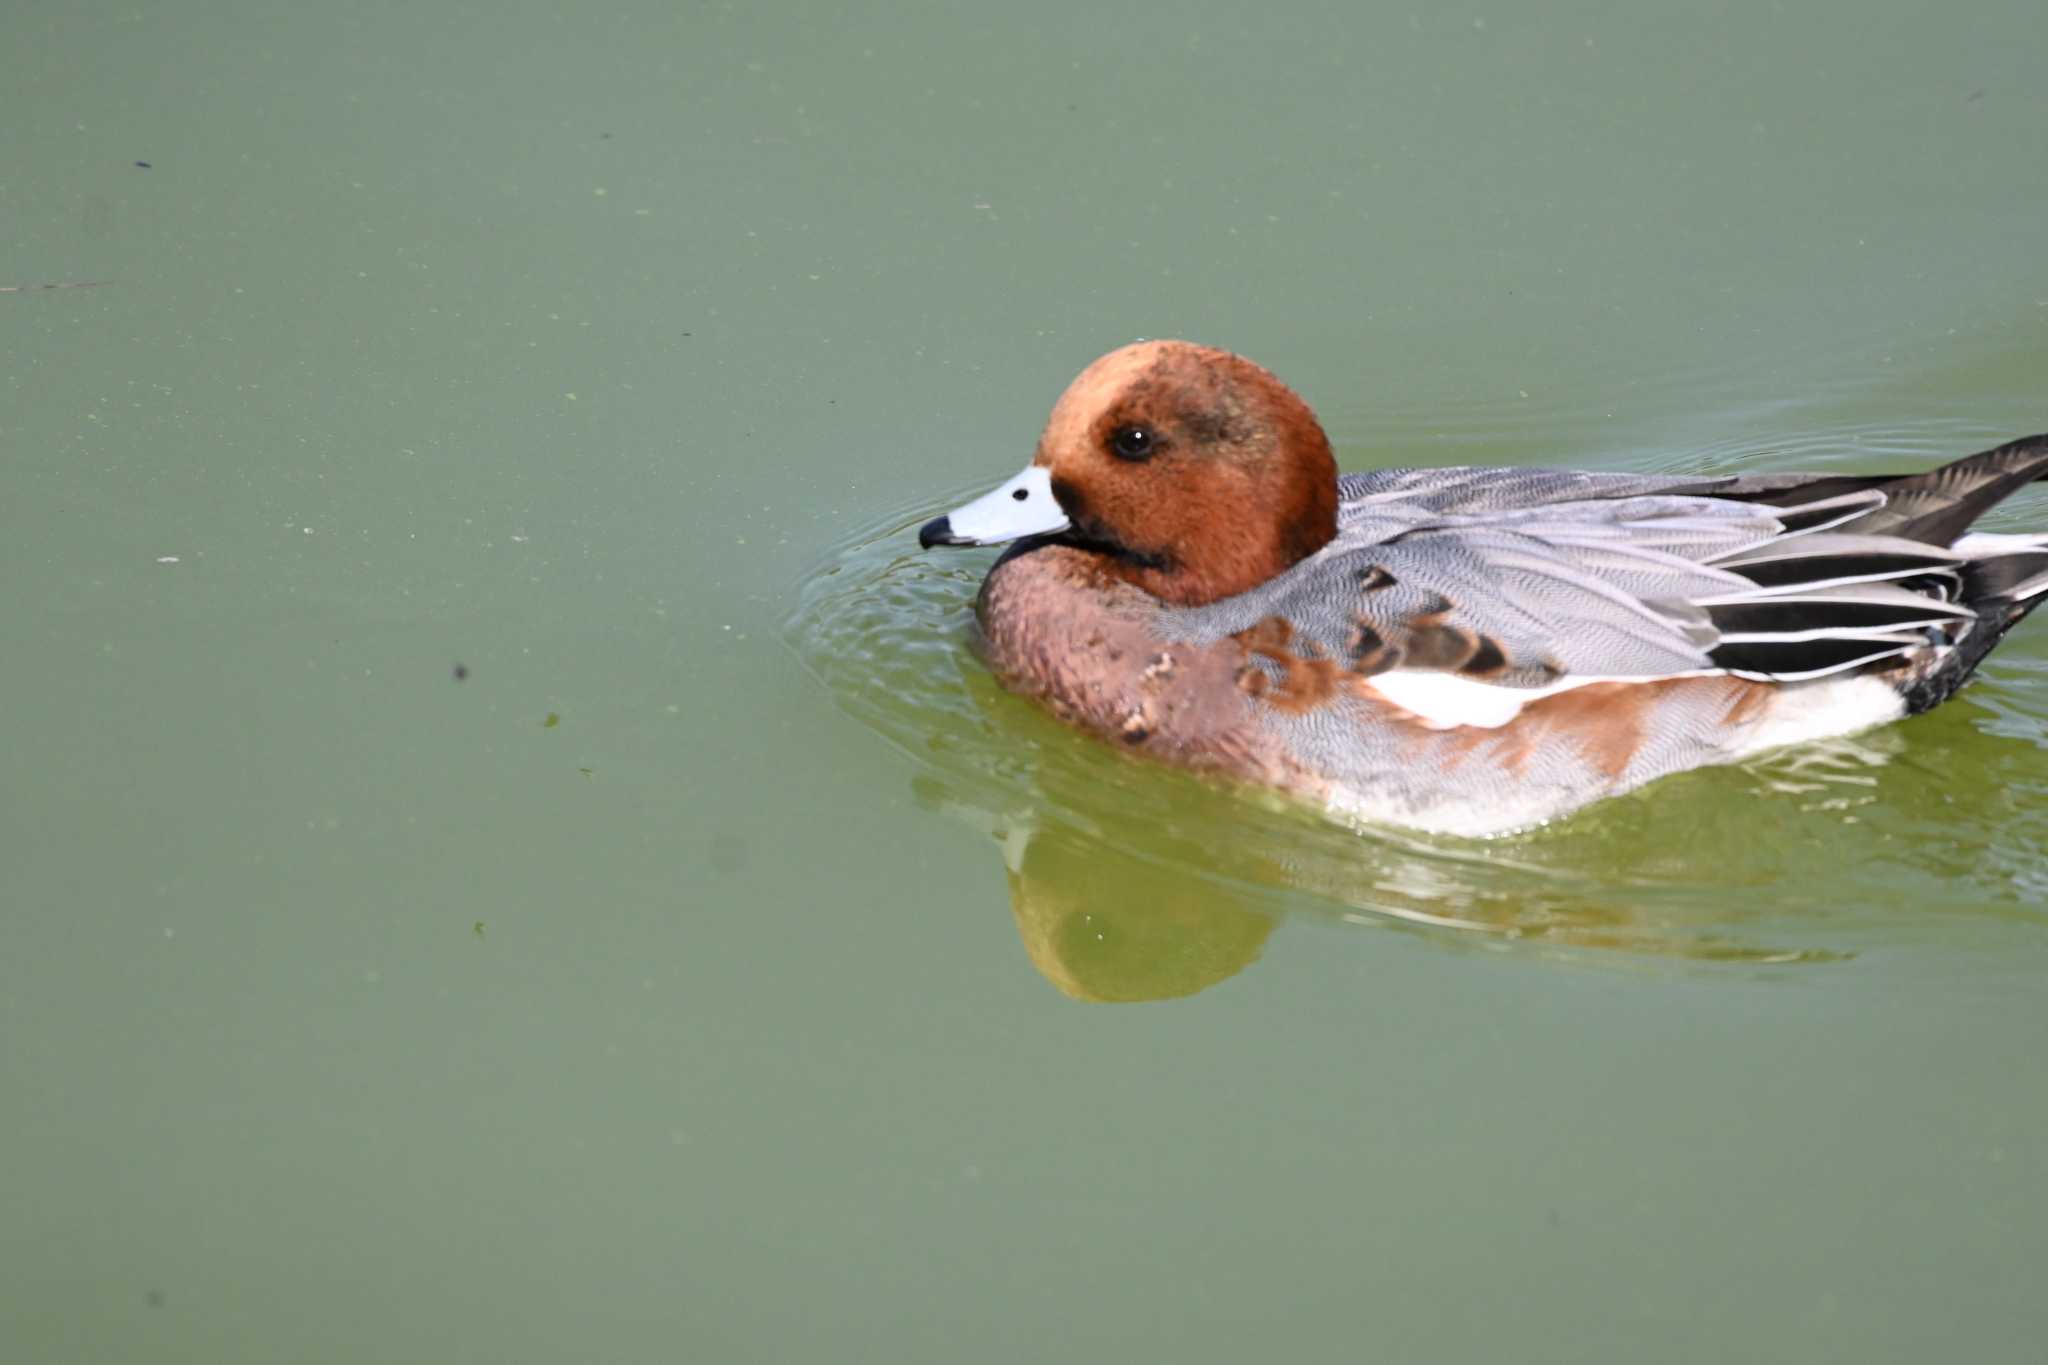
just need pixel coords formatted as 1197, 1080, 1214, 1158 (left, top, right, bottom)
0, 0, 2048, 1365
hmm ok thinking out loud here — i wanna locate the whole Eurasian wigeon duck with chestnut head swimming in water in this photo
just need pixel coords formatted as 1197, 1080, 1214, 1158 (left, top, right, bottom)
918, 342, 2048, 835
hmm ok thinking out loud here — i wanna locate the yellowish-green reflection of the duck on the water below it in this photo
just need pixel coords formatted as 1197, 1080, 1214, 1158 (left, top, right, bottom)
911, 724, 1884, 1003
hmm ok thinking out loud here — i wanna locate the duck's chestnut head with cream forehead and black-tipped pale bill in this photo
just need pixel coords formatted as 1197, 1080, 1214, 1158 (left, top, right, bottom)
918, 342, 1337, 606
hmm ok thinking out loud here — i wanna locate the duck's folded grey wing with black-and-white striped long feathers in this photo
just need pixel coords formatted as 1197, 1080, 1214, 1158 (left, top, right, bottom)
1178, 467, 2048, 694
